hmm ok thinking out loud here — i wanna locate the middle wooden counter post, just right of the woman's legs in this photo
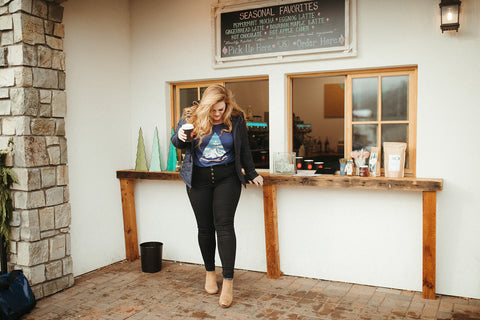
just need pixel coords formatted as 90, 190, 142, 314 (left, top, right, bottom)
263, 185, 282, 279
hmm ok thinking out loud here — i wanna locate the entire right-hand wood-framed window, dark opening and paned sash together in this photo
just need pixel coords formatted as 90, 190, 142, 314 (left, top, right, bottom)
289, 67, 417, 175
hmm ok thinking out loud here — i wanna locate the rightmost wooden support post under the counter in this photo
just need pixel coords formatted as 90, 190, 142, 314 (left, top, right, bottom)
423, 191, 437, 299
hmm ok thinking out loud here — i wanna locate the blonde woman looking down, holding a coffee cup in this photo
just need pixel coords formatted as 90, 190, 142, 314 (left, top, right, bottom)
172, 85, 263, 308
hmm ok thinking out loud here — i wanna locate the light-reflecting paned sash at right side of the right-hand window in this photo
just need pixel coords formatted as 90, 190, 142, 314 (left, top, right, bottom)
346, 69, 417, 175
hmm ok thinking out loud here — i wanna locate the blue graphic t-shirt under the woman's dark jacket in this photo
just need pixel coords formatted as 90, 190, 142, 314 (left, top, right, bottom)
193, 123, 235, 167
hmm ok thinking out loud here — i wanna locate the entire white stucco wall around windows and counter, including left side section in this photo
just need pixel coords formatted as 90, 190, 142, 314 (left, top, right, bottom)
64, 0, 480, 298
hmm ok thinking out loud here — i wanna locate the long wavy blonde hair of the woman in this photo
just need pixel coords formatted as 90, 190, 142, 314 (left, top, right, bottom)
183, 84, 245, 145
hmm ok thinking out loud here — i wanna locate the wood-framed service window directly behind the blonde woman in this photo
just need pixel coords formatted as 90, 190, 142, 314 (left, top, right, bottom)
171, 77, 269, 168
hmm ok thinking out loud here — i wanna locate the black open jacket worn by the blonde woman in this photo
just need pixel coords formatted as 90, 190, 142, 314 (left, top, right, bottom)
171, 115, 258, 188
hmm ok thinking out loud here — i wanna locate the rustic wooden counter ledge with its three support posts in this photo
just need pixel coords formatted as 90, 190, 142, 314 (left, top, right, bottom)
117, 170, 443, 299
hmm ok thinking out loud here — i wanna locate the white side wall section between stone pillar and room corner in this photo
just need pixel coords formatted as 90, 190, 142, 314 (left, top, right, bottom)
64, 0, 132, 275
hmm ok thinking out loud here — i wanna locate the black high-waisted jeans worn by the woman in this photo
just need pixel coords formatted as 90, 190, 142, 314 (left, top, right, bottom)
187, 163, 241, 279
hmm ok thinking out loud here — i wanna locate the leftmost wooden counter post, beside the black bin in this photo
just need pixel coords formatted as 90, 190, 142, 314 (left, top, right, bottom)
120, 179, 140, 261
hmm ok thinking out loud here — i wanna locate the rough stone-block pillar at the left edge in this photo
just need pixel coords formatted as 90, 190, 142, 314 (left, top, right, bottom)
0, 0, 73, 299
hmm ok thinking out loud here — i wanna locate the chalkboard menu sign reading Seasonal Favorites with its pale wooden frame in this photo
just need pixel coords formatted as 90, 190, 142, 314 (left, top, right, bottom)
212, 0, 357, 68
